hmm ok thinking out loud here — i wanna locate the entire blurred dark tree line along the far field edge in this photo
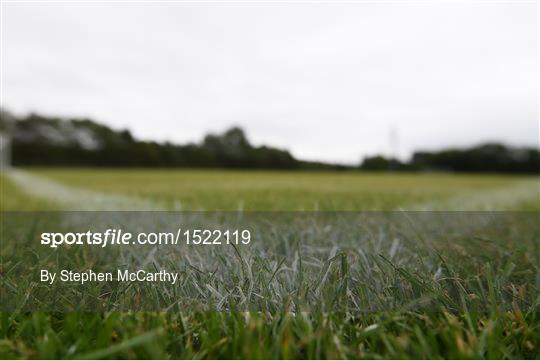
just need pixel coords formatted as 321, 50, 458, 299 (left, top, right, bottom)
0, 110, 540, 174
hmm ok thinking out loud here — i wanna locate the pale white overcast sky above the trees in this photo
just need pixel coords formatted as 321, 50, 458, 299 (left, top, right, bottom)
2, 1, 540, 163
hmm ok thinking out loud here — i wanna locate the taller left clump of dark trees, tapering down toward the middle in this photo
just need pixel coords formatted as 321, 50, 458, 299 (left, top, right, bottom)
2, 113, 302, 169
